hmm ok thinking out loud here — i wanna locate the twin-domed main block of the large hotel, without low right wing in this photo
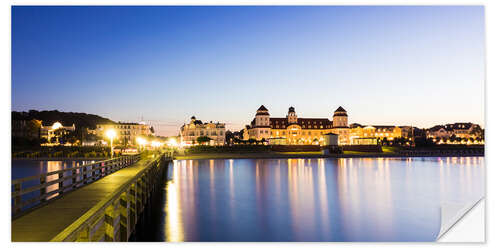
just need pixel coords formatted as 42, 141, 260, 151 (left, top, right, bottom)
244, 105, 350, 145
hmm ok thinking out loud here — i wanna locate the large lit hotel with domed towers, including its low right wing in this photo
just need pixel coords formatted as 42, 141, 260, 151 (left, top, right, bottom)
243, 105, 413, 145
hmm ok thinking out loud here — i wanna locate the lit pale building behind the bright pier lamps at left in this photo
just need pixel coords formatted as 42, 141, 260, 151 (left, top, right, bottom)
96, 122, 153, 145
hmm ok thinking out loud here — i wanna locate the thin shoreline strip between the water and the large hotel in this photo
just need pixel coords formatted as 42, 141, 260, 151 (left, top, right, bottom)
174, 153, 484, 160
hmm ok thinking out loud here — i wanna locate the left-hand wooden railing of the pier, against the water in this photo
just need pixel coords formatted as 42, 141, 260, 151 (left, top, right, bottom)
11, 154, 140, 215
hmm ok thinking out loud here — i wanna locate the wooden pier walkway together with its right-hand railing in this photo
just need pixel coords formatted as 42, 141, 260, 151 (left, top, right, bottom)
11, 153, 172, 242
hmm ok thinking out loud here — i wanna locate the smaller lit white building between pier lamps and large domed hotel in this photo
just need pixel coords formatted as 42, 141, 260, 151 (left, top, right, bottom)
180, 116, 226, 146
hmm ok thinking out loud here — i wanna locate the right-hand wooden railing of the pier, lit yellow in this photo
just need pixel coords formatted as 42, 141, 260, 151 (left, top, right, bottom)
51, 153, 172, 242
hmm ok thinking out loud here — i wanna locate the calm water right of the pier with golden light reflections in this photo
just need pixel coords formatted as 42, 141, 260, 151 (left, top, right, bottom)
133, 157, 484, 241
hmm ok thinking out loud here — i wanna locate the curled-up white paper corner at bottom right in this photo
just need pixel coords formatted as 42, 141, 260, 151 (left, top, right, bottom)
436, 198, 484, 241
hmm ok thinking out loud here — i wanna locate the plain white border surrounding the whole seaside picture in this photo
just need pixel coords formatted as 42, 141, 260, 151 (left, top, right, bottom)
0, 0, 500, 250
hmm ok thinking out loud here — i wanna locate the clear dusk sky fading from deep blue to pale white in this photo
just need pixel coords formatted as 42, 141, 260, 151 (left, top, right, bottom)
12, 6, 485, 135
